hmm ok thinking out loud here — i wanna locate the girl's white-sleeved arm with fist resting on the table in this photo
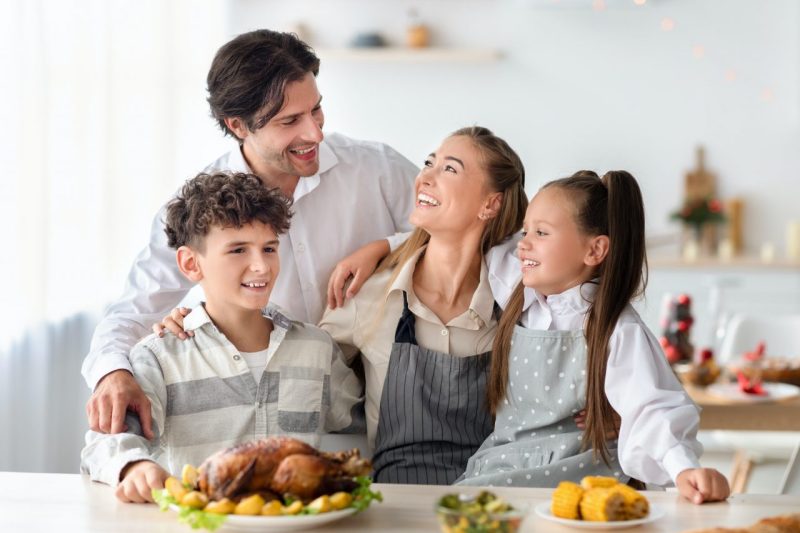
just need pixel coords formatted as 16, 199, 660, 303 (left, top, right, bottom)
605, 315, 730, 503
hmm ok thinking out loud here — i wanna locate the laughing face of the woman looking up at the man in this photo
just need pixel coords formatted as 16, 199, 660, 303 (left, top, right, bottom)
409, 135, 501, 237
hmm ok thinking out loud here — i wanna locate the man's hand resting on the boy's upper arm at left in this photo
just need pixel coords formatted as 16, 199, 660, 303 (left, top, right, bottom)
86, 370, 153, 440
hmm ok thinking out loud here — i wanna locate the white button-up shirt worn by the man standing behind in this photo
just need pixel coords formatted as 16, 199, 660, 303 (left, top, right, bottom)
81, 133, 418, 389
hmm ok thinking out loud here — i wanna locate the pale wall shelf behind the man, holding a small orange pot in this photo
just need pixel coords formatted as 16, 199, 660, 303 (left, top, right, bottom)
314, 47, 502, 63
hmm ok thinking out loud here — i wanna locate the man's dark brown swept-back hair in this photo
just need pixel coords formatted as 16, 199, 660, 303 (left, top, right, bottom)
206, 30, 319, 137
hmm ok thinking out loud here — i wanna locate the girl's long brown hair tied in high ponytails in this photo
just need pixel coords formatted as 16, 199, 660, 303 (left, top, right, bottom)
488, 170, 647, 463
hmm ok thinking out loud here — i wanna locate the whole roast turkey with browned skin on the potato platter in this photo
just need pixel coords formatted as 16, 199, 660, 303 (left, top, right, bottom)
198, 437, 372, 501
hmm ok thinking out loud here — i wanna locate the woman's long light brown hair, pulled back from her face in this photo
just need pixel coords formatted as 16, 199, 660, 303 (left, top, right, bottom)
378, 126, 528, 274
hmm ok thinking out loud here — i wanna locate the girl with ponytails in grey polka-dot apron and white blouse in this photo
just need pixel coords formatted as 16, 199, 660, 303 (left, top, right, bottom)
460, 171, 730, 503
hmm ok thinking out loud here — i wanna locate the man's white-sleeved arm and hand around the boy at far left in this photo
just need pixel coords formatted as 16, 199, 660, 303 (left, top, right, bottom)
81, 208, 192, 435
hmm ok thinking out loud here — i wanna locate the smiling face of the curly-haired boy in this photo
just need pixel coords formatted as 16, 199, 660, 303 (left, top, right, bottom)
193, 221, 280, 314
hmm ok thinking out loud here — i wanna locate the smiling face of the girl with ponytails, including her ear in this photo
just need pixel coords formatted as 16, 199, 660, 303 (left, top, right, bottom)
517, 187, 608, 296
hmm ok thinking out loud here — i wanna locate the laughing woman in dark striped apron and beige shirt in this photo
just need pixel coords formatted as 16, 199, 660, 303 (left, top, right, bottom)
320, 127, 527, 484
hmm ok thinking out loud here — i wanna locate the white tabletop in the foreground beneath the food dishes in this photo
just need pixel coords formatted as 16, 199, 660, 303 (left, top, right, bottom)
0, 472, 800, 533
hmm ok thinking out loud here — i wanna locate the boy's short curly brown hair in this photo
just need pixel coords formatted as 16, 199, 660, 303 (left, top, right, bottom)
164, 172, 292, 251
